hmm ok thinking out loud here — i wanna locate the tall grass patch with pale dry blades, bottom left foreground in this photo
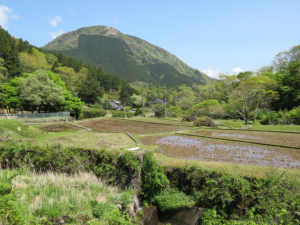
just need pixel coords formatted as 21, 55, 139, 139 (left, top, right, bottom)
0, 170, 136, 224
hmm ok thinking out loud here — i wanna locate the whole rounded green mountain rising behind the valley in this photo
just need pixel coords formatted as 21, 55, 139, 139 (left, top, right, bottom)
42, 26, 211, 85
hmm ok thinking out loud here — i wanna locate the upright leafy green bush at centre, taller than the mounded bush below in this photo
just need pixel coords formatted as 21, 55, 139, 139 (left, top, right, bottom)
142, 153, 169, 203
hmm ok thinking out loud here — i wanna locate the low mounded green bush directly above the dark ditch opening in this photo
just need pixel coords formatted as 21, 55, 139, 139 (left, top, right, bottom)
152, 188, 195, 211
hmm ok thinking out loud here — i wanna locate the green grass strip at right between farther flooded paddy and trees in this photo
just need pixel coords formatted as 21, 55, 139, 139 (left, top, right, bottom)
214, 120, 300, 132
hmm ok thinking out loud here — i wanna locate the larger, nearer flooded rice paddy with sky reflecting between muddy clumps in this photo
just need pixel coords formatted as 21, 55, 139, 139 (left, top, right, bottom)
140, 135, 300, 169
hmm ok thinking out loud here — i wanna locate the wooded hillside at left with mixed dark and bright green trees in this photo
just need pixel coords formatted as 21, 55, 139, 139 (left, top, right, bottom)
0, 29, 139, 116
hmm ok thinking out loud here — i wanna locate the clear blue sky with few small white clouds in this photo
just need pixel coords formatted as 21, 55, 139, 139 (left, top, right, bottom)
0, 0, 300, 77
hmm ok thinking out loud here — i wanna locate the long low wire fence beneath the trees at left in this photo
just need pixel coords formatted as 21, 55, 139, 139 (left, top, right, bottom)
0, 112, 70, 120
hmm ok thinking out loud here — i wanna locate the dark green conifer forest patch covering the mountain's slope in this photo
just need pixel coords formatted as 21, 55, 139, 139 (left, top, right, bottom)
49, 35, 205, 86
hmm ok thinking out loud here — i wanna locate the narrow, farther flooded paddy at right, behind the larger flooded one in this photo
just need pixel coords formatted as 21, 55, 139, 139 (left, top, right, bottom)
190, 130, 300, 148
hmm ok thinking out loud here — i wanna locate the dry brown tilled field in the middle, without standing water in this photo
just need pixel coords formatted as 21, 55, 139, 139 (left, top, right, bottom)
78, 119, 189, 134
